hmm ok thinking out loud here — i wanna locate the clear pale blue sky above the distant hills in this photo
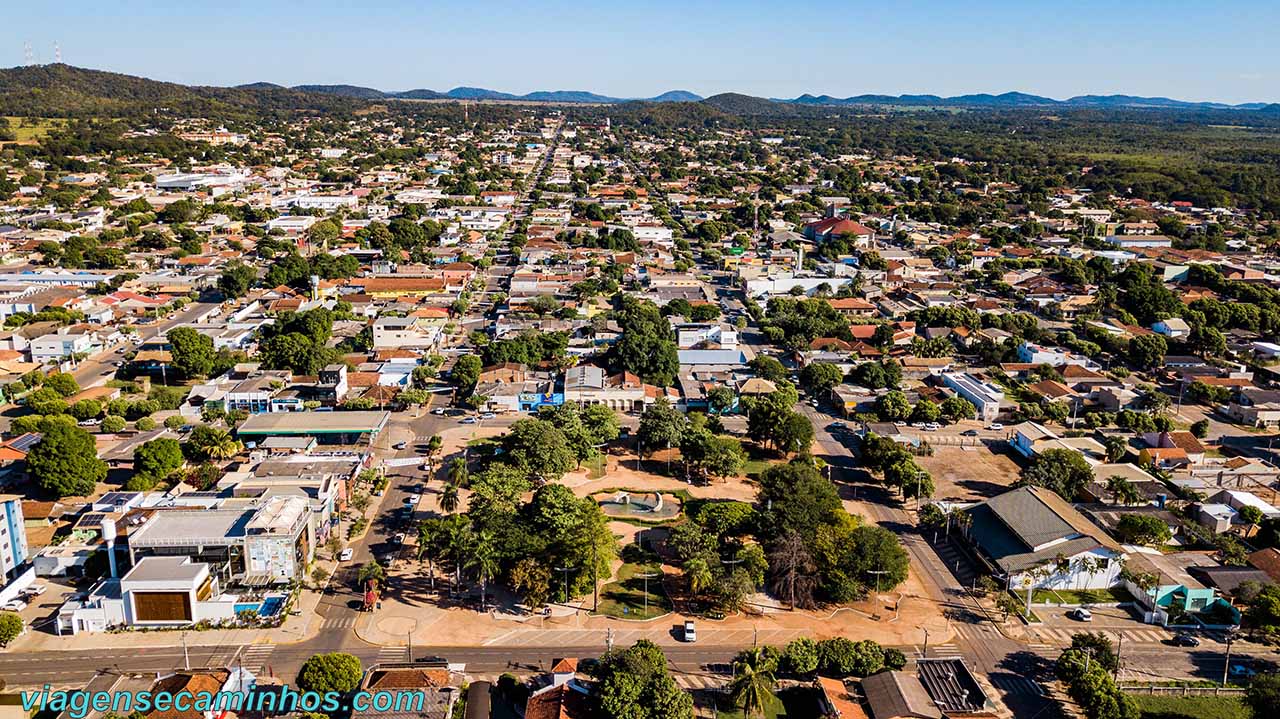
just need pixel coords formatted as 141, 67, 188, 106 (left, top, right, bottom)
0, 0, 1280, 102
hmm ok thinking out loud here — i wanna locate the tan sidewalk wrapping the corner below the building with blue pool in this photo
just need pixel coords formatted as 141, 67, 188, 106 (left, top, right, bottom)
8, 591, 324, 652
